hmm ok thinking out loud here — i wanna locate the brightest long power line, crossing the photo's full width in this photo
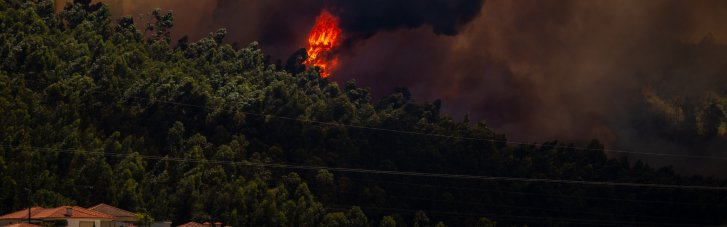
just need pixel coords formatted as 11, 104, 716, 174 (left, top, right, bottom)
5, 145, 727, 191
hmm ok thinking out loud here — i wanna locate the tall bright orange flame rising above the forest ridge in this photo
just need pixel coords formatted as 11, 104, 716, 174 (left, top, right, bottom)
304, 10, 342, 78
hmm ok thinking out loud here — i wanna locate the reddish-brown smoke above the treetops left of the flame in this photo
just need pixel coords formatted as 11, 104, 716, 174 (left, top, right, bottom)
86, 0, 323, 59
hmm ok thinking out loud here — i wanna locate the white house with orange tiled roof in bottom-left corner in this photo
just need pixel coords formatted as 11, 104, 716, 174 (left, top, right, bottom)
0, 206, 113, 227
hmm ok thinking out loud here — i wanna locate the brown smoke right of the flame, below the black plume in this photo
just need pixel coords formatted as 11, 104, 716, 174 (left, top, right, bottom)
334, 0, 727, 176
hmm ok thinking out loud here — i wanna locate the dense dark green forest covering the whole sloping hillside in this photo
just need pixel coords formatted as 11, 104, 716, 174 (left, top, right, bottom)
0, 0, 727, 226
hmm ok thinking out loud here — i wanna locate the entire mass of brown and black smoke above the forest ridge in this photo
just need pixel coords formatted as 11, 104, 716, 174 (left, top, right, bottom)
89, 0, 727, 176
